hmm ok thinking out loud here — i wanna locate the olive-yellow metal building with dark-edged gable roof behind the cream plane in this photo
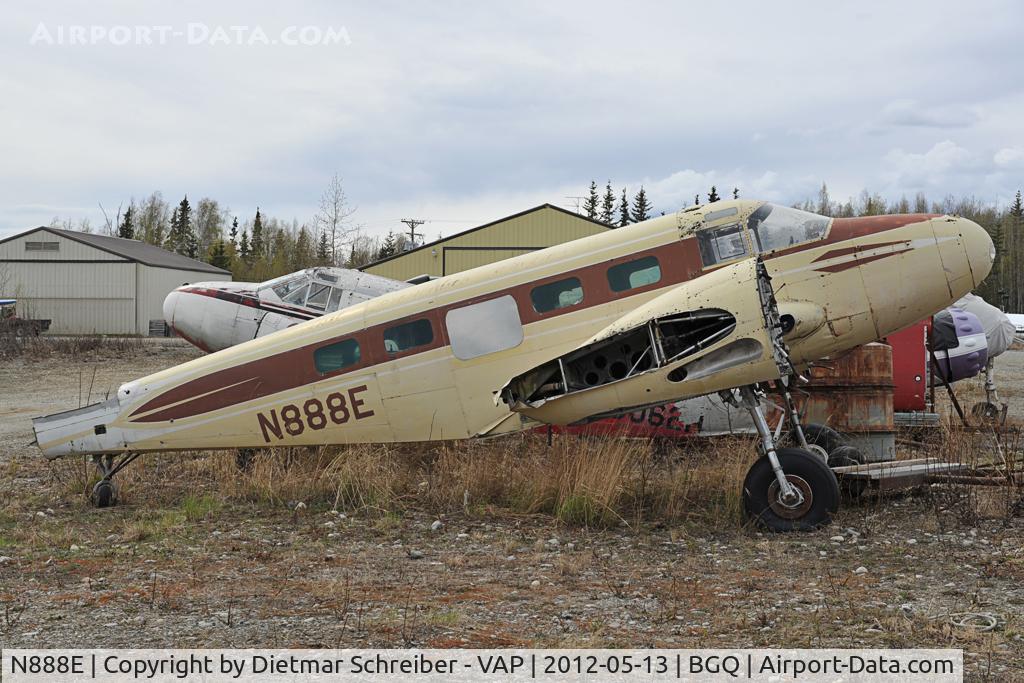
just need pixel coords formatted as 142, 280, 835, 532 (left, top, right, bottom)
361, 204, 611, 280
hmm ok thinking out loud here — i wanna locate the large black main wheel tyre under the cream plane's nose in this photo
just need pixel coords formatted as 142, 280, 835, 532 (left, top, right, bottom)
743, 449, 839, 531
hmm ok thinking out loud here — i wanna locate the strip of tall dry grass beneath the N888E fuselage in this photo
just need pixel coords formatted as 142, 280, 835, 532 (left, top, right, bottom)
37, 434, 754, 535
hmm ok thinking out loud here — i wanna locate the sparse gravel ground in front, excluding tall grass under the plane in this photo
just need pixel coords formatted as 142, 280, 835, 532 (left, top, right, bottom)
0, 345, 1024, 681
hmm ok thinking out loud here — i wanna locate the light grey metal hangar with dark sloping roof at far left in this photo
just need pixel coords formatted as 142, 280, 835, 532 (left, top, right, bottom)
0, 227, 231, 335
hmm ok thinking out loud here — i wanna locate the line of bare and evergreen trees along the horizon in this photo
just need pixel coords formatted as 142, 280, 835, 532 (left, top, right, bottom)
51, 175, 1024, 312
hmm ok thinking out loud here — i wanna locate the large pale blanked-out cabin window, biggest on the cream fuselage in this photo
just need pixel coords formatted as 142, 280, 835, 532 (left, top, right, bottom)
444, 296, 522, 360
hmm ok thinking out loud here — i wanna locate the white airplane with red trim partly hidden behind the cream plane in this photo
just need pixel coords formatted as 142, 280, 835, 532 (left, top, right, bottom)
164, 267, 412, 352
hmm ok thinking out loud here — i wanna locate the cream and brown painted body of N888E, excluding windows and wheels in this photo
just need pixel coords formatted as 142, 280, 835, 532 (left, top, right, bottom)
36, 201, 991, 457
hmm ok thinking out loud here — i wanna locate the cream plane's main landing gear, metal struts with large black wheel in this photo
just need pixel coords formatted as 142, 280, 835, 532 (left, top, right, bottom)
733, 386, 840, 531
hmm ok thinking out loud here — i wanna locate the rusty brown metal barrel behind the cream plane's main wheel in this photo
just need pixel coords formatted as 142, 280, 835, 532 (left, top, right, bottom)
798, 343, 896, 462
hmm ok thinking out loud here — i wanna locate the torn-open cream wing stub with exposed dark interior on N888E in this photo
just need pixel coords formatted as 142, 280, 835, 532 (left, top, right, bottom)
498, 258, 788, 424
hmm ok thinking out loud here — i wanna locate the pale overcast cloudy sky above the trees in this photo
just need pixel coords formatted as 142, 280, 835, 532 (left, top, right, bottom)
0, 0, 1024, 239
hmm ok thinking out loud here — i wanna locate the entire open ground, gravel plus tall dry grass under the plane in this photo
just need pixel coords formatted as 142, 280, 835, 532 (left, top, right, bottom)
0, 344, 1024, 680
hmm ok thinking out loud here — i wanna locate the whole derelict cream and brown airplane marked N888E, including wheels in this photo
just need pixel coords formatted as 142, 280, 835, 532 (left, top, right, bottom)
33, 200, 994, 531
